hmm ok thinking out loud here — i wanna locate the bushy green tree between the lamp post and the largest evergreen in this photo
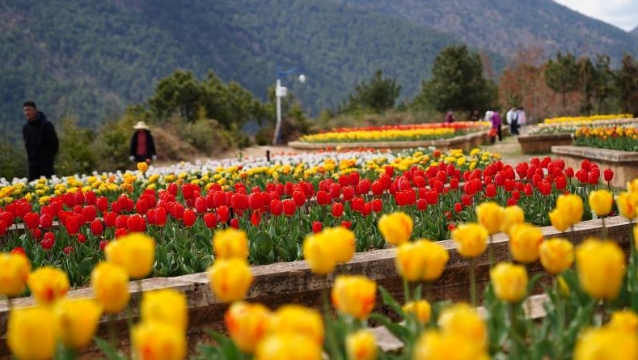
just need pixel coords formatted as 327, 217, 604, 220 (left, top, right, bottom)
340, 69, 401, 113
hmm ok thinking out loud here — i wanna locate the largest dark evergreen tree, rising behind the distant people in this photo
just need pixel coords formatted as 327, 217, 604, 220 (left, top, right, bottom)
412, 45, 498, 113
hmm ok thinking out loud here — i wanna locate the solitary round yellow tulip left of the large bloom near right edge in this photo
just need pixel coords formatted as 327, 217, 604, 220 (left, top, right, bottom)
490, 263, 528, 303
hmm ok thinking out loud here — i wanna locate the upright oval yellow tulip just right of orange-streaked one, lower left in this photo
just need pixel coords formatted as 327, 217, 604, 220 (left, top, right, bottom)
91, 262, 131, 314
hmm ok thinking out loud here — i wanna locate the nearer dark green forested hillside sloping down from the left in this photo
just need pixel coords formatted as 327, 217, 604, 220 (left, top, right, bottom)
0, 0, 455, 128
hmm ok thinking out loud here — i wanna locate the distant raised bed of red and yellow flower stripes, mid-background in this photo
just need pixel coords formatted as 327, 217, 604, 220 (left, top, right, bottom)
299, 122, 490, 143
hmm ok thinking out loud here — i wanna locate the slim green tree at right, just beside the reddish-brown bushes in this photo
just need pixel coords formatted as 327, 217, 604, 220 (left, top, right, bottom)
545, 52, 580, 110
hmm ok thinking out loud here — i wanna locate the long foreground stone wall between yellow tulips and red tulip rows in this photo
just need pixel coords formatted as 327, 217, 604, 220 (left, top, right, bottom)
0, 217, 631, 358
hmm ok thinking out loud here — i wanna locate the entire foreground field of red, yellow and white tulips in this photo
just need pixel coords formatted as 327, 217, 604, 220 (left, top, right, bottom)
0, 143, 638, 360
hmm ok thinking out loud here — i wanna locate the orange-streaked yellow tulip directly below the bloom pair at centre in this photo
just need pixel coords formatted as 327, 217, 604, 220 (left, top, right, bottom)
331, 275, 377, 320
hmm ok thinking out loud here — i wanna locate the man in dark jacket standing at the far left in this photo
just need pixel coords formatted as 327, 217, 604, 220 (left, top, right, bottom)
22, 101, 59, 181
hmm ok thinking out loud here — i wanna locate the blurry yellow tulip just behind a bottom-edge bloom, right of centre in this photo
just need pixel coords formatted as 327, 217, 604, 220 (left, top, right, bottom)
438, 303, 487, 347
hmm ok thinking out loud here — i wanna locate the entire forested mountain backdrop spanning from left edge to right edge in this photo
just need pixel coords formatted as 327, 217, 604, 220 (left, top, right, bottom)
0, 0, 638, 129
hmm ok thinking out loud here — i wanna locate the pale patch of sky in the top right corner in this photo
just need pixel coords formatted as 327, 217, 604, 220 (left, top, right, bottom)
554, 0, 638, 30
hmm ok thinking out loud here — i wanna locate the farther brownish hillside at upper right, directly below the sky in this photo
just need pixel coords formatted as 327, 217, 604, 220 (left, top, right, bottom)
330, 0, 638, 62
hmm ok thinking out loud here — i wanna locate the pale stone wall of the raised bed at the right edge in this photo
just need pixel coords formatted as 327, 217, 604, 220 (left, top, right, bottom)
552, 146, 638, 188
